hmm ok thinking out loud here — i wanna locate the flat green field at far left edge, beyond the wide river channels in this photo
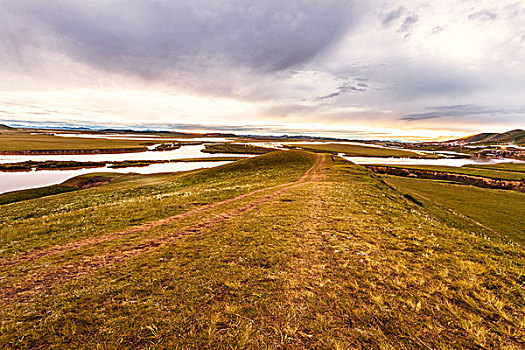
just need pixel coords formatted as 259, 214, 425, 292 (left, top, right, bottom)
0, 132, 152, 151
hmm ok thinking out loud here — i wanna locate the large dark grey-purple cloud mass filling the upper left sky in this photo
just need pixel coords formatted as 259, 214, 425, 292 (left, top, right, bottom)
0, 0, 355, 77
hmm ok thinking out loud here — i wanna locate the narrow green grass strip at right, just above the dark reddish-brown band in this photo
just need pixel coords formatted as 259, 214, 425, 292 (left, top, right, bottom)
370, 164, 525, 180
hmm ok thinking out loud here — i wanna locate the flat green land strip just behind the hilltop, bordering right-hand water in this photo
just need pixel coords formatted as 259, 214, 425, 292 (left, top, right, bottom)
289, 143, 439, 158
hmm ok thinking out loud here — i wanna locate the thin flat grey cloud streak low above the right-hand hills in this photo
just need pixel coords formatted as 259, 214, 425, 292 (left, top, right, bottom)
401, 105, 525, 121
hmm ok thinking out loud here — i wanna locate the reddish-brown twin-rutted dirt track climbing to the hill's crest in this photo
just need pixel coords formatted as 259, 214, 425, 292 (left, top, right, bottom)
0, 154, 326, 303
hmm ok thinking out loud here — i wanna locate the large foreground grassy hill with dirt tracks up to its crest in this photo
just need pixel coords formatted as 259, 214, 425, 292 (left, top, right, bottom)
0, 151, 525, 349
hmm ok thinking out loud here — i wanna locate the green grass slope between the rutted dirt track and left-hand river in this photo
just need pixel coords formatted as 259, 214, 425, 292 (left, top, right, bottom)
0, 152, 312, 258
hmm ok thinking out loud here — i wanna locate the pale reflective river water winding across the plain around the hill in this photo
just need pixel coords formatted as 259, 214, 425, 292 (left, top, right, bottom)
0, 134, 519, 194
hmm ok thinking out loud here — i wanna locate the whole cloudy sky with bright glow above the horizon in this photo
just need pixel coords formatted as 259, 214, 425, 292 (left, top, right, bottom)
0, 0, 525, 140
